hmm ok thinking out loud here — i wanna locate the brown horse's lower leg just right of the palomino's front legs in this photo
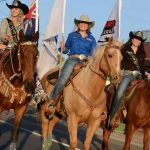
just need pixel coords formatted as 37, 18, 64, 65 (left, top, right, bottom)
100, 127, 112, 150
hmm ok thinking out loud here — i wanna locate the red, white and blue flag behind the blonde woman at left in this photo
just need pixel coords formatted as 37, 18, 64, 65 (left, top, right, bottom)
24, 0, 38, 35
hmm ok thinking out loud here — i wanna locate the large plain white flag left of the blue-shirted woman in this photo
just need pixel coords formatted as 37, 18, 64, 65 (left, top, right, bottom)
37, 0, 66, 79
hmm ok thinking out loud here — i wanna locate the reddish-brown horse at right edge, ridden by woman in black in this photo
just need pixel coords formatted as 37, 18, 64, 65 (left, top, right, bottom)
123, 80, 150, 150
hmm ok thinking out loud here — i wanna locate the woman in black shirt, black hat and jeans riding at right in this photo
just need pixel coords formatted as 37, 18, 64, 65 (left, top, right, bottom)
106, 31, 150, 129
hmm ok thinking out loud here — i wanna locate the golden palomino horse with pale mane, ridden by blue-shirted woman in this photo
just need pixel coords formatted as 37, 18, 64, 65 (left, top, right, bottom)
41, 40, 122, 150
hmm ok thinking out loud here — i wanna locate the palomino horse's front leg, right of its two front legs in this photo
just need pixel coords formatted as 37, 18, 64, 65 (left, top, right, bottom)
84, 118, 101, 150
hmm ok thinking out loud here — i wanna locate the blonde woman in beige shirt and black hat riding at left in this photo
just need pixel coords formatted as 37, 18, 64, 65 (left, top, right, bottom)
0, 0, 29, 69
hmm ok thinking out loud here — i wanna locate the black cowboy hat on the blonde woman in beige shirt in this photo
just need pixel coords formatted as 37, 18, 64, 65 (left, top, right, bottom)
6, 0, 29, 15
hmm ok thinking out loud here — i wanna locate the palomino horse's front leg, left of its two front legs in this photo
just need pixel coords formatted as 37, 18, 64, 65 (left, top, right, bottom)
67, 114, 78, 150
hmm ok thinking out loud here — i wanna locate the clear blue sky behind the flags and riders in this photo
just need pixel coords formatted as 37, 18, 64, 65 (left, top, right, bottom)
0, 0, 150, 44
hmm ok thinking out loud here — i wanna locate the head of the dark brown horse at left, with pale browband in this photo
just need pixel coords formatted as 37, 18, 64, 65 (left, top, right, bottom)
18, 31, 39, 94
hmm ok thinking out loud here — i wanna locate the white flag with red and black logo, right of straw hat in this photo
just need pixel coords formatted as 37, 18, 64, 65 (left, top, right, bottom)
98, 0, 122, 45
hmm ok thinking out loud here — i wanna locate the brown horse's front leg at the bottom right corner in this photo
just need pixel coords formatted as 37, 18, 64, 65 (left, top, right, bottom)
143, 127, 150, 150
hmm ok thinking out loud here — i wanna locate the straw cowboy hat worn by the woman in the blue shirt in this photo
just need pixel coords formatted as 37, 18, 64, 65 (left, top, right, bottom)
74, 15, 95, 29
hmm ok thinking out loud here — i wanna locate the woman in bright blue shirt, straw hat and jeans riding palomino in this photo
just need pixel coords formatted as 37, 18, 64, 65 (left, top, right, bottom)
48, 15, 96, 116
